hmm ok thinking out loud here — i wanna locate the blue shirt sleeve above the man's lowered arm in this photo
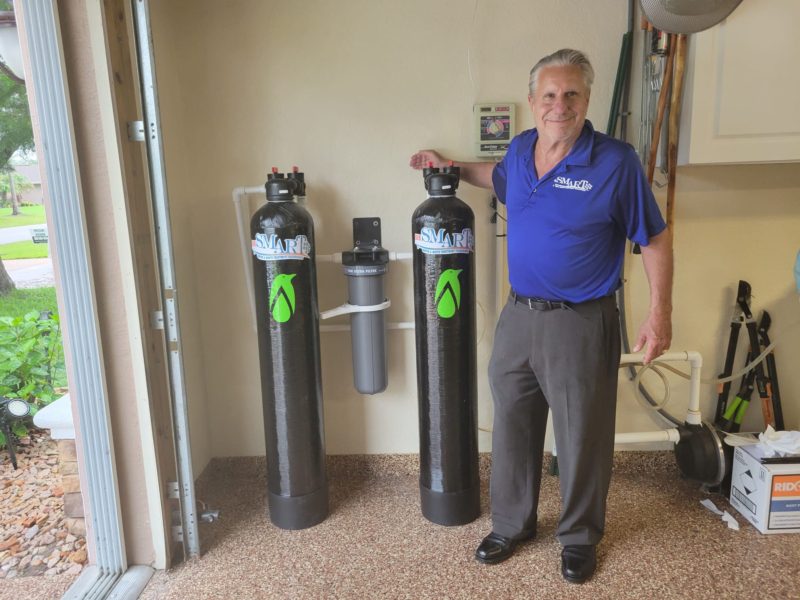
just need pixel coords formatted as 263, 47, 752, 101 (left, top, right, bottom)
612, 146, 667, 246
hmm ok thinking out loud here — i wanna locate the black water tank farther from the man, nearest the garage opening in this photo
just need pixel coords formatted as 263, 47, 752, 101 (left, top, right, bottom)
250, 169, 328, 529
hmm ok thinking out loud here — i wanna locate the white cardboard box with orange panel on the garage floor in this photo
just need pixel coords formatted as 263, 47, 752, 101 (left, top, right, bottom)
731, 445, 800, 533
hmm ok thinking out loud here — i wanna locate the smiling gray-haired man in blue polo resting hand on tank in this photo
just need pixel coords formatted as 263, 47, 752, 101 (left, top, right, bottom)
410, 49, 672, 583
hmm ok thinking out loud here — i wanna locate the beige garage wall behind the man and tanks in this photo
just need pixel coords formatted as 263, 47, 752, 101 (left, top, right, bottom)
152, 0, 800, 467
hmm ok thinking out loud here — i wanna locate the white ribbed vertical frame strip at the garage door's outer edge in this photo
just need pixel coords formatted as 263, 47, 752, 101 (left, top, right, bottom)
17, 0, 162, 599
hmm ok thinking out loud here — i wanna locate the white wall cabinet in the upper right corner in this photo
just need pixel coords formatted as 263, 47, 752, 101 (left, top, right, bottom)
678, 0, 800, 164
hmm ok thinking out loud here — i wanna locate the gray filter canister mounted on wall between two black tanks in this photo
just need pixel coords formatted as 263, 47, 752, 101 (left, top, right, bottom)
342, 217, 389, 394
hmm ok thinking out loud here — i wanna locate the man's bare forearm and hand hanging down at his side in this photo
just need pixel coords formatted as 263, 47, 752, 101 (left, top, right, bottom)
633, 229, 672, 364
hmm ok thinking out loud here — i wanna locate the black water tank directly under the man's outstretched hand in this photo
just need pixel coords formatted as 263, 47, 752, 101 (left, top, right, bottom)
412, 166, 480, 525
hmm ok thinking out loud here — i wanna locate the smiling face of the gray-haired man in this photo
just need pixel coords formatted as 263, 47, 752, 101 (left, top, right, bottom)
528, 66, 589, 142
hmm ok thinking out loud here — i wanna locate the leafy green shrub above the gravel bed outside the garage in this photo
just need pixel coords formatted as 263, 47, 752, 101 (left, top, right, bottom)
0, 287, 62, 447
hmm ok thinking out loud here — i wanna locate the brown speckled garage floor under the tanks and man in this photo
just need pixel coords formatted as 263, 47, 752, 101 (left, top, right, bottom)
134, 452, 800, 600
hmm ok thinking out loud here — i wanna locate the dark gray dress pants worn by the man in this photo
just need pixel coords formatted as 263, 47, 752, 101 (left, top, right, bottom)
489, 296, 620, 545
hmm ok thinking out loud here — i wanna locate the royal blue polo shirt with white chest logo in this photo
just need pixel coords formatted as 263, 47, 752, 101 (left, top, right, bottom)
492, 121, 666, 302
